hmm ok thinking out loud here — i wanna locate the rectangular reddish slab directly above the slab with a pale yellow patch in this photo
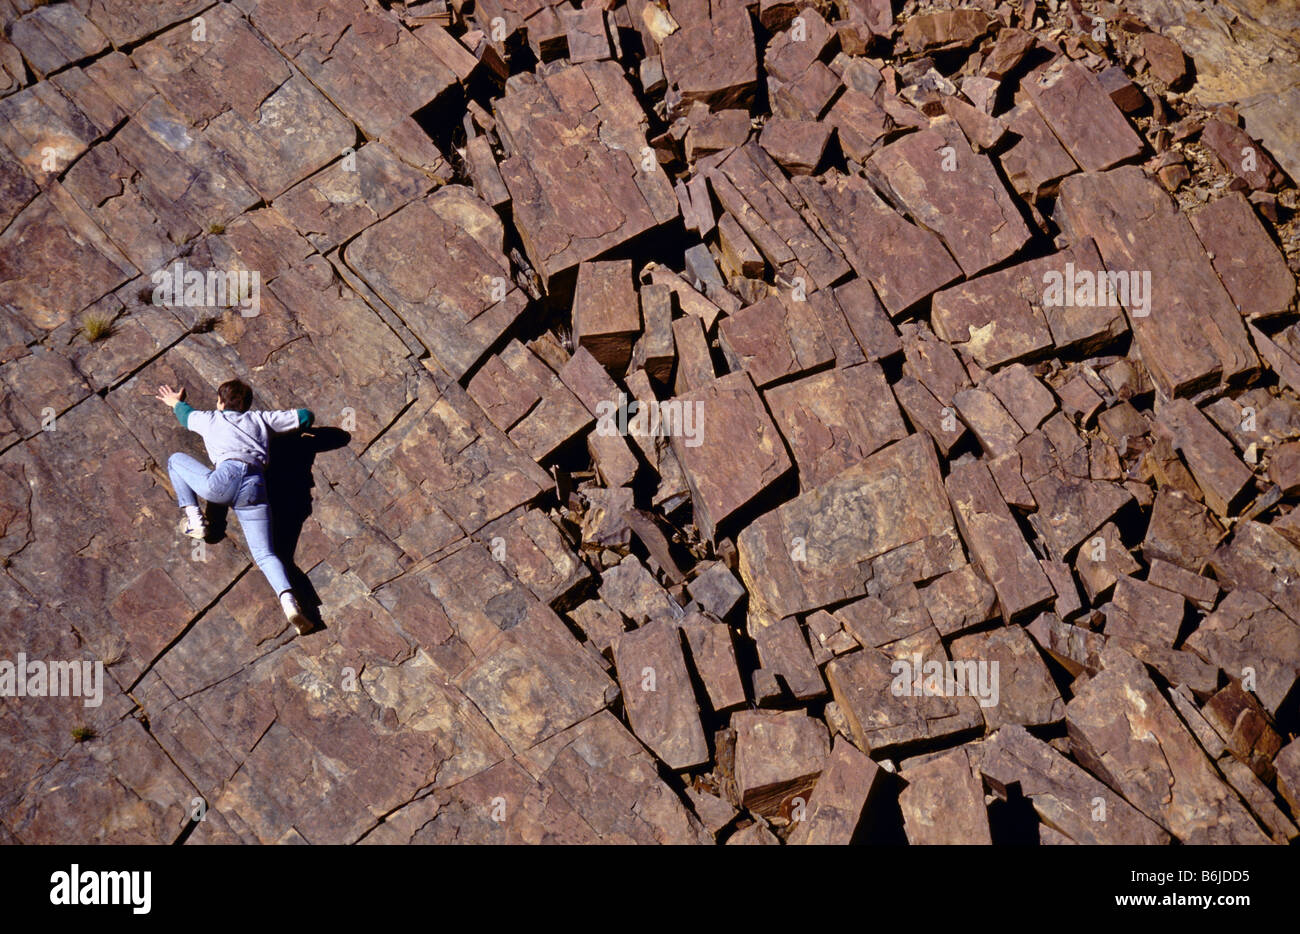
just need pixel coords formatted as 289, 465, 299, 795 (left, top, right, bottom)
867, 120, 1030, 276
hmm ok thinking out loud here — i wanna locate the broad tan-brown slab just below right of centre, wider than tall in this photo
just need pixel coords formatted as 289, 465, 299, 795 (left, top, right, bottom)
737, 434, 965, 619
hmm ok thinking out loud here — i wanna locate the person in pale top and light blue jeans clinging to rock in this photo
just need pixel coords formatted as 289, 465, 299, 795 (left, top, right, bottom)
156, 380, 313, 635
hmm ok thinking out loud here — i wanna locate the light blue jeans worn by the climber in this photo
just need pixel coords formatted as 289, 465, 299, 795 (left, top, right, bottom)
166, 454, 293, 594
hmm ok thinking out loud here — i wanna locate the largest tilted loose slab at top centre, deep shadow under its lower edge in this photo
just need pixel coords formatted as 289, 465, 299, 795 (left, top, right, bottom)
497, 61, 679, 287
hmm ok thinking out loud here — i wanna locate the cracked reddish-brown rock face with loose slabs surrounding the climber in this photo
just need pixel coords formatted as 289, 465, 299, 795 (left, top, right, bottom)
0, 0, 1300, 846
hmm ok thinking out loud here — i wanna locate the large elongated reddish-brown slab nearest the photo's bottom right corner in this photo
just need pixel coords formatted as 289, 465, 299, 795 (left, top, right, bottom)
1066, 648, 1268, 844
